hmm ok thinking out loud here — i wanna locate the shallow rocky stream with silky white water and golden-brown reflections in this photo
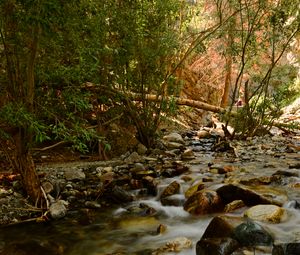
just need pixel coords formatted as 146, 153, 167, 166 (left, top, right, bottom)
0, 133, 300, 255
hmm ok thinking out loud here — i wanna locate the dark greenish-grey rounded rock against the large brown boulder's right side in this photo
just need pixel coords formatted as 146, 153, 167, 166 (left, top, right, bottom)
233, 220, 274, 247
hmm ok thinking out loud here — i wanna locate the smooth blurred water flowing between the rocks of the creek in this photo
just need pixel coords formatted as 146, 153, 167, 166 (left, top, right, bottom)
0, 137, 300, 255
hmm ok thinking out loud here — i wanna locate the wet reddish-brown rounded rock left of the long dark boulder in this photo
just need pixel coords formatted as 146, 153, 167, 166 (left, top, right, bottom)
184, 189, 224, 215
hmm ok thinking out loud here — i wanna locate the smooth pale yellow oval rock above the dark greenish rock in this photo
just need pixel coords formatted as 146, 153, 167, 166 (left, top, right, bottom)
244, 205, 286, 223
